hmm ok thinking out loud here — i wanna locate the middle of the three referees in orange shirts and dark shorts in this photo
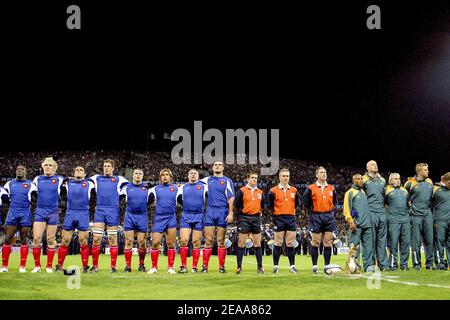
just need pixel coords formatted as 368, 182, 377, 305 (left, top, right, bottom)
267, 169, 300, 274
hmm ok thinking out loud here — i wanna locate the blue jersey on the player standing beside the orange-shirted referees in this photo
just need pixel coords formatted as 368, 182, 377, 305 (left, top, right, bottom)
200, 176, 234, 208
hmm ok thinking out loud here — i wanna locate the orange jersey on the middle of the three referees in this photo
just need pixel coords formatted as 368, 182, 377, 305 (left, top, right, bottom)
267, 185, 300, 215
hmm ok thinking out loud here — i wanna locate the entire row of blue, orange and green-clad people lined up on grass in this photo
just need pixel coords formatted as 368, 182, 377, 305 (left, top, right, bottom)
0, 158, 450, 274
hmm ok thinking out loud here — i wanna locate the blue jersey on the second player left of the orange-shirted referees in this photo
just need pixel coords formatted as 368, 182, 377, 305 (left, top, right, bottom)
177, 181, 208, 214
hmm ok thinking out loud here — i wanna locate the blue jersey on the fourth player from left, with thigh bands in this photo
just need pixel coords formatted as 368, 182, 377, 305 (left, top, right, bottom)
90, 174, 129, 207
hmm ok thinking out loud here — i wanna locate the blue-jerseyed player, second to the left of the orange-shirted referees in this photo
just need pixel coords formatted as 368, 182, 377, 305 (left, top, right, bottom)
177, 169, 208, 273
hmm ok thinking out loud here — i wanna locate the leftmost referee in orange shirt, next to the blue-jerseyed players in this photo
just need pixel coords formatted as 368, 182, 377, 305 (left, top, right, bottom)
234, 172, 264, 274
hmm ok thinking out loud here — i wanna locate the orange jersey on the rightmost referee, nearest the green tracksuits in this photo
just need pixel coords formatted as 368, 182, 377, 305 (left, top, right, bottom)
304, 183, 337, 213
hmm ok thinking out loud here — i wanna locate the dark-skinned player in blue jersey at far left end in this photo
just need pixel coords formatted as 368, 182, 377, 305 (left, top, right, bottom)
0, 165, 37, 273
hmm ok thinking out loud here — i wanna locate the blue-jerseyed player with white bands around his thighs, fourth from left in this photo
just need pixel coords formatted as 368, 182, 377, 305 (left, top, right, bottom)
90, 159, 128, 273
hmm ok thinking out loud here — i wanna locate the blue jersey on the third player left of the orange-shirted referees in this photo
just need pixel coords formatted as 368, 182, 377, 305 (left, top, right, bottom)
149, 183, 178, 215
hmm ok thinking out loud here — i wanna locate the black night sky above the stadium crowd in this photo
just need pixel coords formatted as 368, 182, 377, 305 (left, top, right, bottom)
1, 1, 450, 175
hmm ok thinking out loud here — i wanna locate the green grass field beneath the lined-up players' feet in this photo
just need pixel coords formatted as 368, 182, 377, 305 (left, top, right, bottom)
0, 254, 450, 300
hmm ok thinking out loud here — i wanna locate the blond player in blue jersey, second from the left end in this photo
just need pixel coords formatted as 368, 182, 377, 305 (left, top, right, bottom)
31, 158, 63, 273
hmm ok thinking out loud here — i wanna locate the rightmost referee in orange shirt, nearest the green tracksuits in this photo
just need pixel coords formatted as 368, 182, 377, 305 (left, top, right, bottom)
303, 167, 338, 273
